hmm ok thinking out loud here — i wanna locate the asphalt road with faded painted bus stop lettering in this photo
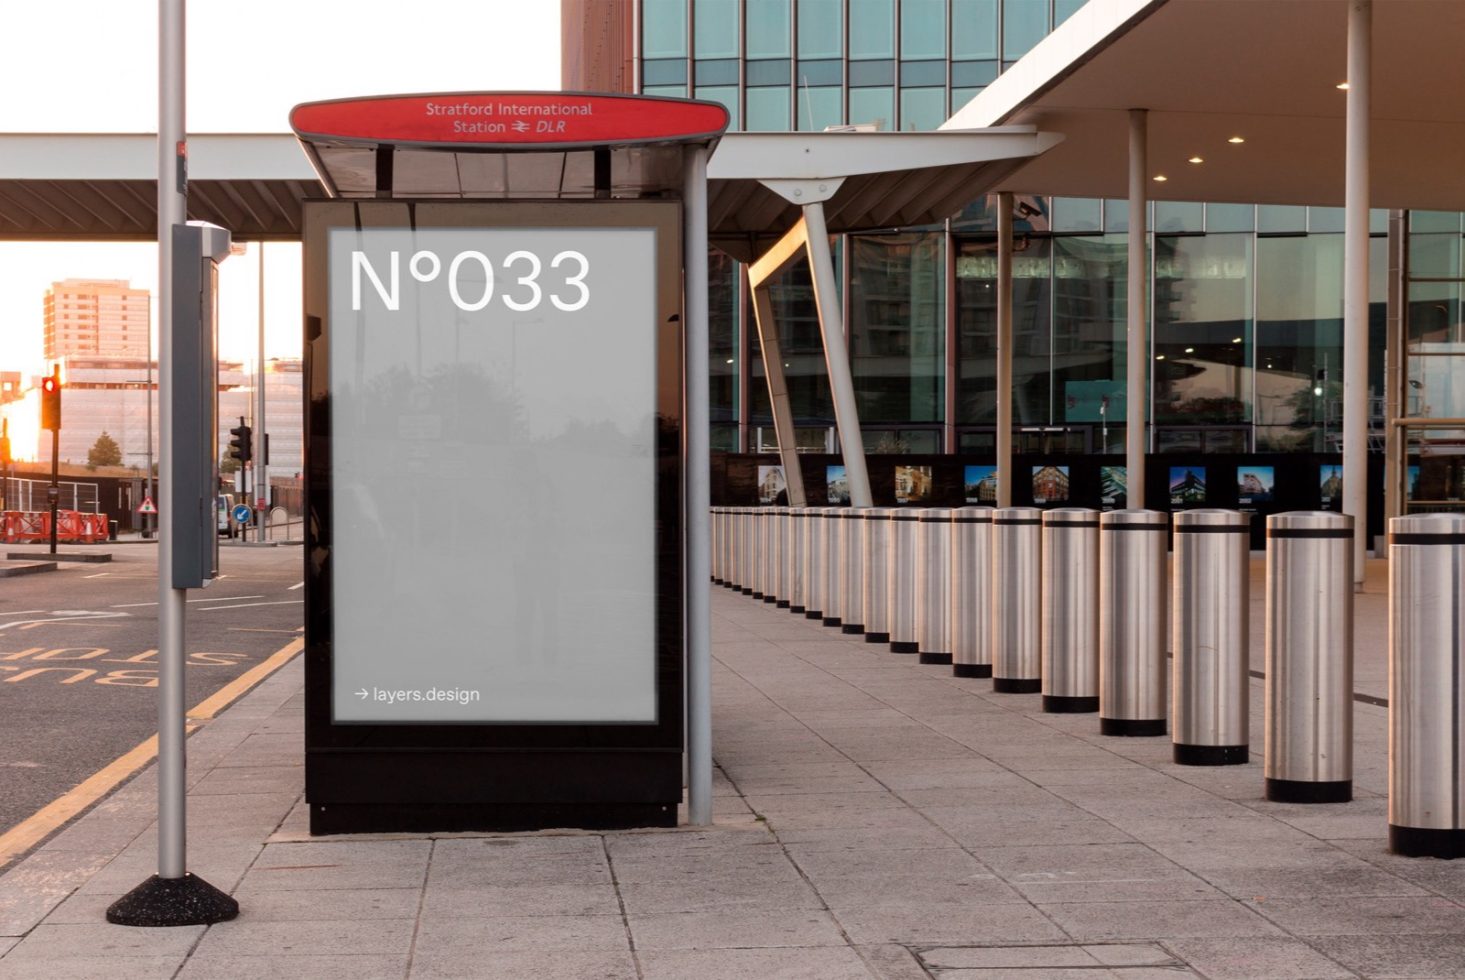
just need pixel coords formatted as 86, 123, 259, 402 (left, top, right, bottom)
0, 543, 305, 867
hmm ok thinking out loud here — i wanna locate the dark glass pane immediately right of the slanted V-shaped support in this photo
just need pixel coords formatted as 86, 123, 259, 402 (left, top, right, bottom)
850, 231, 946, 422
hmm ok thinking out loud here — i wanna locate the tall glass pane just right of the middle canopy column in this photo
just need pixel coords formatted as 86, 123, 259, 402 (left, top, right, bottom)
1151, 234, 1253, 425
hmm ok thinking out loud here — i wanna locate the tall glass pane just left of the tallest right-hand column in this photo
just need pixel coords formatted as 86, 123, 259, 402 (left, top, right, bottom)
1253, 234, 1343, 453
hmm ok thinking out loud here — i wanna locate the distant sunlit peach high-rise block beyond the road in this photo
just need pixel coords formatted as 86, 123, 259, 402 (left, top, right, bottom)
45, 278, 151, 362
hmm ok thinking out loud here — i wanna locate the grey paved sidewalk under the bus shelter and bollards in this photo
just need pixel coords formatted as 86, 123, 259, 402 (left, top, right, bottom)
0, 579, 1465, 980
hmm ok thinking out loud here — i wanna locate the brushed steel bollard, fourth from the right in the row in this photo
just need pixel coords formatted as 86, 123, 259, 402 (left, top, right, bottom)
1099, 510, 1171, 735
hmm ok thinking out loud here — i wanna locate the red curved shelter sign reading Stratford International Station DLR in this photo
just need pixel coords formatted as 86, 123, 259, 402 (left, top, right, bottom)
290, 92, 730, 146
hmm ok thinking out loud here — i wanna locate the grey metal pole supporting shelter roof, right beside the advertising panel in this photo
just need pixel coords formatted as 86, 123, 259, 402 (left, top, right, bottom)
683, 146, 712, 826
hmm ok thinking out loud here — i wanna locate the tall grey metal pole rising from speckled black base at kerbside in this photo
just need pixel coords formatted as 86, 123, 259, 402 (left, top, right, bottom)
158, 0, 188, 879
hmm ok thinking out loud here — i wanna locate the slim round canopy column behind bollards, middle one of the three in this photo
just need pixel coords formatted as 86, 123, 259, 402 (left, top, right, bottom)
1124, 108, 1150, 510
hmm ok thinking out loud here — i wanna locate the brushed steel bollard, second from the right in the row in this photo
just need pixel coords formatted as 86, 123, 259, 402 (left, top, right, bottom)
1263, 511, 1354, 803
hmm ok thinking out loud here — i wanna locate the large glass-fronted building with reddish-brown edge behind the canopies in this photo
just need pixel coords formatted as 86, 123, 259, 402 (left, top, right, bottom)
563, 0, 1418, 516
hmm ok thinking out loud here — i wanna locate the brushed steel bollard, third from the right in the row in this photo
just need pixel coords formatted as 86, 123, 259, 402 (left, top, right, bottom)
1171, 510, 1251, 766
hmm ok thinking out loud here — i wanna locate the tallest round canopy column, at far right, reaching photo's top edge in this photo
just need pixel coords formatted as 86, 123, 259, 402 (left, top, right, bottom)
1343, 0, 1373, 589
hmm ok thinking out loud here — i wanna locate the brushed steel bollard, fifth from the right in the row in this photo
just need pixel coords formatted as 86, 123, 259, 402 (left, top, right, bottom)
1040, 507, 1099, 713
